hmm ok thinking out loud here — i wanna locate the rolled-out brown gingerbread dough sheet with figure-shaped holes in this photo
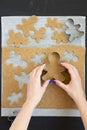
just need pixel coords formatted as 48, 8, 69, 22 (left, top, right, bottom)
2, 45, 85, 108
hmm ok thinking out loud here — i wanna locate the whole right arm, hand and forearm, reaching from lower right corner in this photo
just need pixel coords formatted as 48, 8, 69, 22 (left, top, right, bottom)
56, 63, 87, 130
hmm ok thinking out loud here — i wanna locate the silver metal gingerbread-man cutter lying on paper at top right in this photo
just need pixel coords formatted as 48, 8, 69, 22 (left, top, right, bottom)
65, 19, 84, 42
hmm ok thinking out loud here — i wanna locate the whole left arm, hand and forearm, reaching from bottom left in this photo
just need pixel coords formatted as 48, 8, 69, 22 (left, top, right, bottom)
9, 64, 49, 130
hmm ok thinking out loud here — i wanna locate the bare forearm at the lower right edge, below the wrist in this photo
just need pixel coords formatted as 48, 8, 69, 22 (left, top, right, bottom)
76, 97, 87, 130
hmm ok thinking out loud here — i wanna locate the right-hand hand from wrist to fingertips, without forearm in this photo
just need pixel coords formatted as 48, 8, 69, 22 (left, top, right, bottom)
55, 62, 85, 103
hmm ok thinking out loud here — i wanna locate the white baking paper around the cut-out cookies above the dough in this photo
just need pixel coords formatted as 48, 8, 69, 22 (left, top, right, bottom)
1, 16, 85, 48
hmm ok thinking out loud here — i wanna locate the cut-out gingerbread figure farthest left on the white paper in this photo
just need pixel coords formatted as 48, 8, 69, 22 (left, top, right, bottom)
7, 30, 29, 47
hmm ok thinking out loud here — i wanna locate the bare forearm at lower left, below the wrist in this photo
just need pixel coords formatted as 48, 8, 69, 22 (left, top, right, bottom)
9, 102, 34, 130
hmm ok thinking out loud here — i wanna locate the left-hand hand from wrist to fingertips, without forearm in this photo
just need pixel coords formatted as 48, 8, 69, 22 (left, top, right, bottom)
26, 64, 49, 107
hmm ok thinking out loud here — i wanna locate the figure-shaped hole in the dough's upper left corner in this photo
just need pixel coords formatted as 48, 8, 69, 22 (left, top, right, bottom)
6, 51, 28, 69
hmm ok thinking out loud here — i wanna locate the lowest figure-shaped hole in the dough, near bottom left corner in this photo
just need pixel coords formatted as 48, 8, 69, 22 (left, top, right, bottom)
7, 92, 23, 105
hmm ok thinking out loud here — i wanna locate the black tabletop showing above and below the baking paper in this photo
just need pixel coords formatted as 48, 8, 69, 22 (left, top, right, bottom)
0, 0, 87, 130
